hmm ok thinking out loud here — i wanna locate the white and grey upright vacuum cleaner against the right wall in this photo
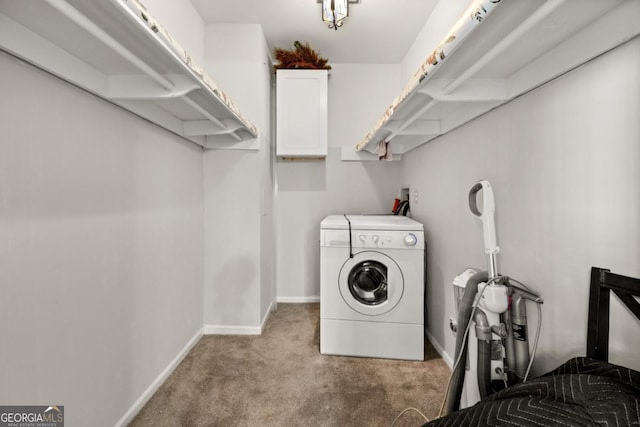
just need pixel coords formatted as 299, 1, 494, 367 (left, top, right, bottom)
443, 180, 543, 414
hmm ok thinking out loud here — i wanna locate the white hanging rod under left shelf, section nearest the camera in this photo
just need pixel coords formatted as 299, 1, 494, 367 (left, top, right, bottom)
45, 0, 174, 90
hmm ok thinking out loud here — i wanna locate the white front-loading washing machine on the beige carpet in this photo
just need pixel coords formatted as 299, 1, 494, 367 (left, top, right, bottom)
320, 215, 425, 360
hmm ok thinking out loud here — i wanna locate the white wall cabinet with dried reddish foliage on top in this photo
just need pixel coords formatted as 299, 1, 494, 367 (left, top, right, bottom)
276, 70, 328, 158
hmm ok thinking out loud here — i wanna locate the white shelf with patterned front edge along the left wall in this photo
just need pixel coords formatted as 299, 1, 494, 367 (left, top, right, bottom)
0, 0, 259, 149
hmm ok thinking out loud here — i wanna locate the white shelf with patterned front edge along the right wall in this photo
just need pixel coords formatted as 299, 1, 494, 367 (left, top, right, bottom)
355, 0, 640, 159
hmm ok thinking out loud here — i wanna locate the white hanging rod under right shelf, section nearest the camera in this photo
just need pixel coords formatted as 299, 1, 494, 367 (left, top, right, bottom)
443, 0, 566, 95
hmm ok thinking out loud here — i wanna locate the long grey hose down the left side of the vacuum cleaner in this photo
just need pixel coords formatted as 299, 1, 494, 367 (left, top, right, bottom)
445, 271, 491, 414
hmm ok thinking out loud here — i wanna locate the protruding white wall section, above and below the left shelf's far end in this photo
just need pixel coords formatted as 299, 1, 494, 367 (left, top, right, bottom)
204, 24, 275, 333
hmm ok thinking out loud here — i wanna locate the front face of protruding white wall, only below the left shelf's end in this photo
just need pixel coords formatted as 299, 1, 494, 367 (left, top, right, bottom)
204, 150, 261, 333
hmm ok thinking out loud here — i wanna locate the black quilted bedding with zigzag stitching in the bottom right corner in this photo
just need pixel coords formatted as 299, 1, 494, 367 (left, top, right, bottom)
425, 357, 640, 427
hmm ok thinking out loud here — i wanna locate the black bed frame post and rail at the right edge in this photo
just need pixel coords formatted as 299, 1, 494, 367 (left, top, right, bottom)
587, 267, 640, 362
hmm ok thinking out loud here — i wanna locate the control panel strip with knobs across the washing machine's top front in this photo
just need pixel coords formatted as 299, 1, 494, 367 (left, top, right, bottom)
320, 230, 424, 249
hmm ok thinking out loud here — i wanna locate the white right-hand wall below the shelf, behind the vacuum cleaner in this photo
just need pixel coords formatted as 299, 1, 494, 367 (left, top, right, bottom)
403, 35, 640, 372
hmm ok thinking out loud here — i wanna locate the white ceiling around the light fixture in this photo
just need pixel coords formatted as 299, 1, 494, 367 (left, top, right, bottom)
191, 0, 438, 64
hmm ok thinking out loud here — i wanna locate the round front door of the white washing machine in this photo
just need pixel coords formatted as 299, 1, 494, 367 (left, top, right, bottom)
339, 251, 404, 316
